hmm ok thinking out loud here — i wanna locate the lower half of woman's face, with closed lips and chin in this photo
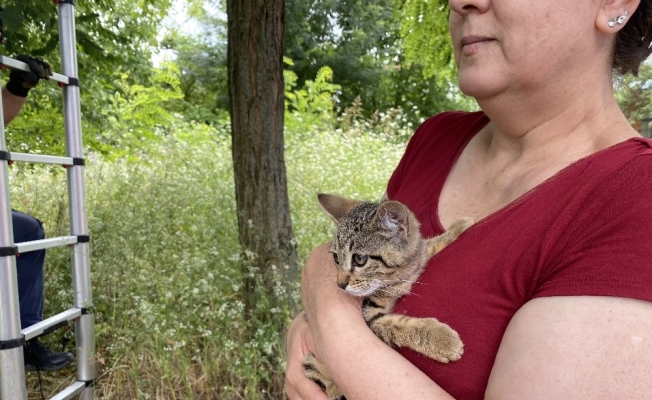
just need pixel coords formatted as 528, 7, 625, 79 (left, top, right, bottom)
449, 0, 608, 99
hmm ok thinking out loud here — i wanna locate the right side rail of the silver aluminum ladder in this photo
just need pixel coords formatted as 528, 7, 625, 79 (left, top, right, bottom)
58, 1, 97, 400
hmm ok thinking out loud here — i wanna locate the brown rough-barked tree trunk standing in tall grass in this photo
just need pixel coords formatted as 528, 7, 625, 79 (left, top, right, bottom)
227, 0, 297, 313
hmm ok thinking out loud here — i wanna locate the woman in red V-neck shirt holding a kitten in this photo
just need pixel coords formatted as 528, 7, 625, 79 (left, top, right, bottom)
286, 0, 652, 400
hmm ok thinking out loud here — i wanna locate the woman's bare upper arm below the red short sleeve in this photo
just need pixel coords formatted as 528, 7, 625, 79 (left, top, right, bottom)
485, 296, 652, 400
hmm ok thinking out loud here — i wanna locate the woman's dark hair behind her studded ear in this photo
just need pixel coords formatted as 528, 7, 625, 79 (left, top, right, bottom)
613, 0, 652, 75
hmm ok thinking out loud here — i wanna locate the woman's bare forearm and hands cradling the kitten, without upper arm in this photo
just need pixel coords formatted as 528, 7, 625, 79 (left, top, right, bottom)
286, 245, 452, 400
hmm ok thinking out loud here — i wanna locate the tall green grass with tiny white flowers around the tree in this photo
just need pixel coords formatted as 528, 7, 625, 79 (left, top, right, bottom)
11, 119, 404, 399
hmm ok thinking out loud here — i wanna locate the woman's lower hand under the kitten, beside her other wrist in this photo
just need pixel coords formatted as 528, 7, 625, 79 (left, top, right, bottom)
285, 312, 328, 400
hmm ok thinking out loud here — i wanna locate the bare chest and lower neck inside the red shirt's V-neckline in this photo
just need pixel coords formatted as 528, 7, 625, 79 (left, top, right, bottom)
438, 92, 639, 227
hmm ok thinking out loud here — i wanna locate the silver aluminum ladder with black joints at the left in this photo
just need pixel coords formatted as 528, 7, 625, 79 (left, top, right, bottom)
0, 0, 97, 400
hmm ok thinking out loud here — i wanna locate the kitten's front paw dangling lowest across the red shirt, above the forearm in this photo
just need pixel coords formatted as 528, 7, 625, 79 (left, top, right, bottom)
415, 318, 464, 363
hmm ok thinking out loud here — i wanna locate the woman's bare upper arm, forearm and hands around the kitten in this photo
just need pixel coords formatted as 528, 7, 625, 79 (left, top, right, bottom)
288, 246, 652, 400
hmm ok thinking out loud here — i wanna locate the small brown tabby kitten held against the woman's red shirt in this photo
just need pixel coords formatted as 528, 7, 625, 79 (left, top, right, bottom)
303, 194, 473, 400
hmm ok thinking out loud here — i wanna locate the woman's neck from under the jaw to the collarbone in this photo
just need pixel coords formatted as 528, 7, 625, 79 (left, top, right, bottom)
478, 83, 638, 163
